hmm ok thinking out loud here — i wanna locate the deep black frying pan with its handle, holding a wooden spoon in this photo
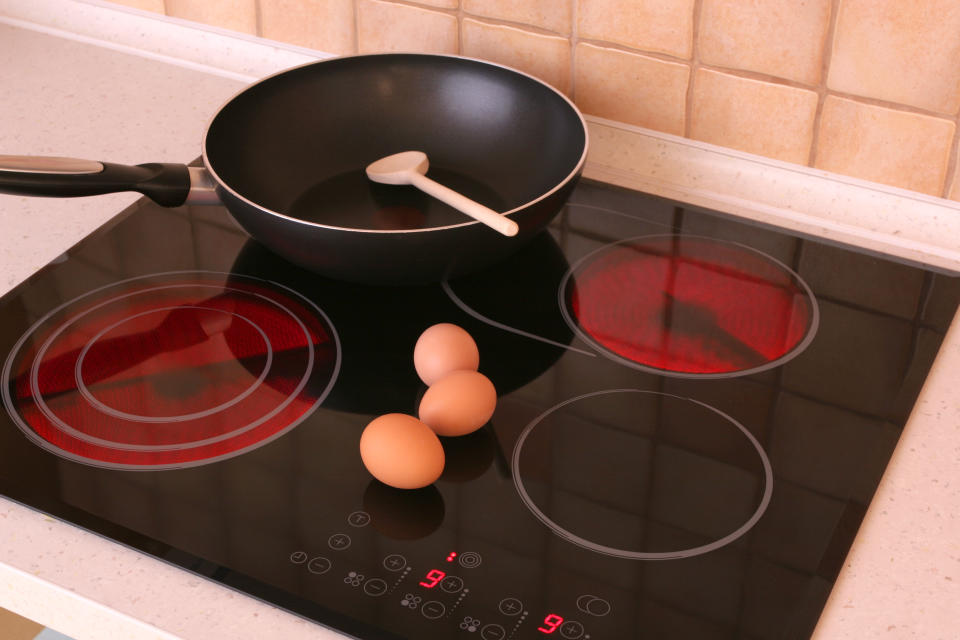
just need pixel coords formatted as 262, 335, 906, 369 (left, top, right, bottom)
0, 54, 587, 284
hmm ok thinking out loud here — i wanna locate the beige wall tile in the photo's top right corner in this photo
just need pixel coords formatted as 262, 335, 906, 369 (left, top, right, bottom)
828, 0, 960, 114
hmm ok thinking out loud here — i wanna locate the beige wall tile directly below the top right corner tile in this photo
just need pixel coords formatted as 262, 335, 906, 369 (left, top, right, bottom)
816, 96, 956, 196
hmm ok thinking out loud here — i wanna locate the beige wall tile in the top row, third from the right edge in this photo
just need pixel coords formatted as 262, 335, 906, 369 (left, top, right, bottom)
577, 0, 694, 58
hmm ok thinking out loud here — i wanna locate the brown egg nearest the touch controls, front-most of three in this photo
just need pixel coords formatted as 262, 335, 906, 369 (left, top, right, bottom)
360, 413, 444, 489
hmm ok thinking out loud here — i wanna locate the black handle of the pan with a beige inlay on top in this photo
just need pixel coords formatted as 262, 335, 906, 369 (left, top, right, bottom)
0, 155, 190, 207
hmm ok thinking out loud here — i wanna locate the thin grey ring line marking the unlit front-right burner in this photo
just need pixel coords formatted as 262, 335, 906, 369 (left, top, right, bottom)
511, 389, 773, 560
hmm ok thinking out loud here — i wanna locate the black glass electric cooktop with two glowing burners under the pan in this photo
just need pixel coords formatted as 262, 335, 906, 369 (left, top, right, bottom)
0, 176, 960, 640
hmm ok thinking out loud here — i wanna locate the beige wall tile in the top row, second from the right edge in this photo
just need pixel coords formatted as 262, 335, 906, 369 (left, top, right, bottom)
699, 0, 831, 84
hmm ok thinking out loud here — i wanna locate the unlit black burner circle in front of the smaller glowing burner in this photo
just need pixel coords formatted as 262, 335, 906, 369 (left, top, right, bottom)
512, 389, 773, 560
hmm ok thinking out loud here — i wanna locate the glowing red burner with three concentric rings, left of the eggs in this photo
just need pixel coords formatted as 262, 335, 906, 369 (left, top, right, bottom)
3, 272, 340, 469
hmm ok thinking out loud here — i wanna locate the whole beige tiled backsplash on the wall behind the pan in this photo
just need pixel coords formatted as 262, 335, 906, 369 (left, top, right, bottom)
107, 0, 960, 200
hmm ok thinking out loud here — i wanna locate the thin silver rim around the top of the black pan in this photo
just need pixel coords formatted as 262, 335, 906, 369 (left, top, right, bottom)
201, 51, 590, 234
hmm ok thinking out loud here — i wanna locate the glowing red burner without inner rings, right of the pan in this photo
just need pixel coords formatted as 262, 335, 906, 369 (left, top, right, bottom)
563, 236, 817, 376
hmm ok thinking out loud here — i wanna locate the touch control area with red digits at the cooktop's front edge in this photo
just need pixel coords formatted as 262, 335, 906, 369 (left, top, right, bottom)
288, 509, 617, 640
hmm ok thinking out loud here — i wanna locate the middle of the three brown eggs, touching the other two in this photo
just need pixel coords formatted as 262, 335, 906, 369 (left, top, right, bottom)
419, 371, 497, 436
